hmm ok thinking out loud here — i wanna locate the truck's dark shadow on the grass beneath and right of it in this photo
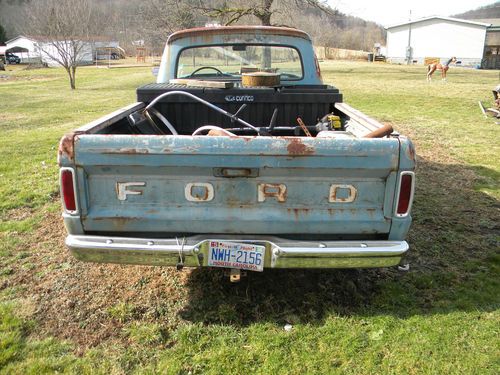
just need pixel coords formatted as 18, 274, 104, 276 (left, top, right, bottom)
182, 160, 500, 325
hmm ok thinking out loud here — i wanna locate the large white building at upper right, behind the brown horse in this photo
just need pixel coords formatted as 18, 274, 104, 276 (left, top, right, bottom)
386, 17, 490, 66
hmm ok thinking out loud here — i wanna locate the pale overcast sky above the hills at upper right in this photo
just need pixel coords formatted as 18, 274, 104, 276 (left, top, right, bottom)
328, 0, 495, 26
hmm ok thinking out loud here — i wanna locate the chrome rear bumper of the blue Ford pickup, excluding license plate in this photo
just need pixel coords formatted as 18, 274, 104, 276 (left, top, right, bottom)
66, 235, 408, 268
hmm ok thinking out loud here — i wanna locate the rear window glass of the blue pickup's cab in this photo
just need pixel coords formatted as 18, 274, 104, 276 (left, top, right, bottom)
176, 44, 303, 81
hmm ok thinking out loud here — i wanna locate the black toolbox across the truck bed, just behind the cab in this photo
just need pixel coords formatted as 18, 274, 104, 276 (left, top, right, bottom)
96, 83, 342, 135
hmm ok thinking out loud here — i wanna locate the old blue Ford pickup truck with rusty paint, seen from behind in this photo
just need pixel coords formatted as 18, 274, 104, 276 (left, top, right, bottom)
58, 27, 415, 274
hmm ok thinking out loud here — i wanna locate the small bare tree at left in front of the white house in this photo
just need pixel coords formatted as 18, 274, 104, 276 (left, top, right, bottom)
27, 0, 103, 90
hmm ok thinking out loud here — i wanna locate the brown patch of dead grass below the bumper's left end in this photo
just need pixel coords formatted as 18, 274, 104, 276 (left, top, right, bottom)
2, 213, 190, 351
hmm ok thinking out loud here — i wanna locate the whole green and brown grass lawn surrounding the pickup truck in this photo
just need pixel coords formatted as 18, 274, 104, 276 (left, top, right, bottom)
0, 62, 500, 374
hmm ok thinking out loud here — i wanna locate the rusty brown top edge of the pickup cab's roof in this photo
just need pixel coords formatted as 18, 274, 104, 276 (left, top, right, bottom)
167, 26, 311, 44
